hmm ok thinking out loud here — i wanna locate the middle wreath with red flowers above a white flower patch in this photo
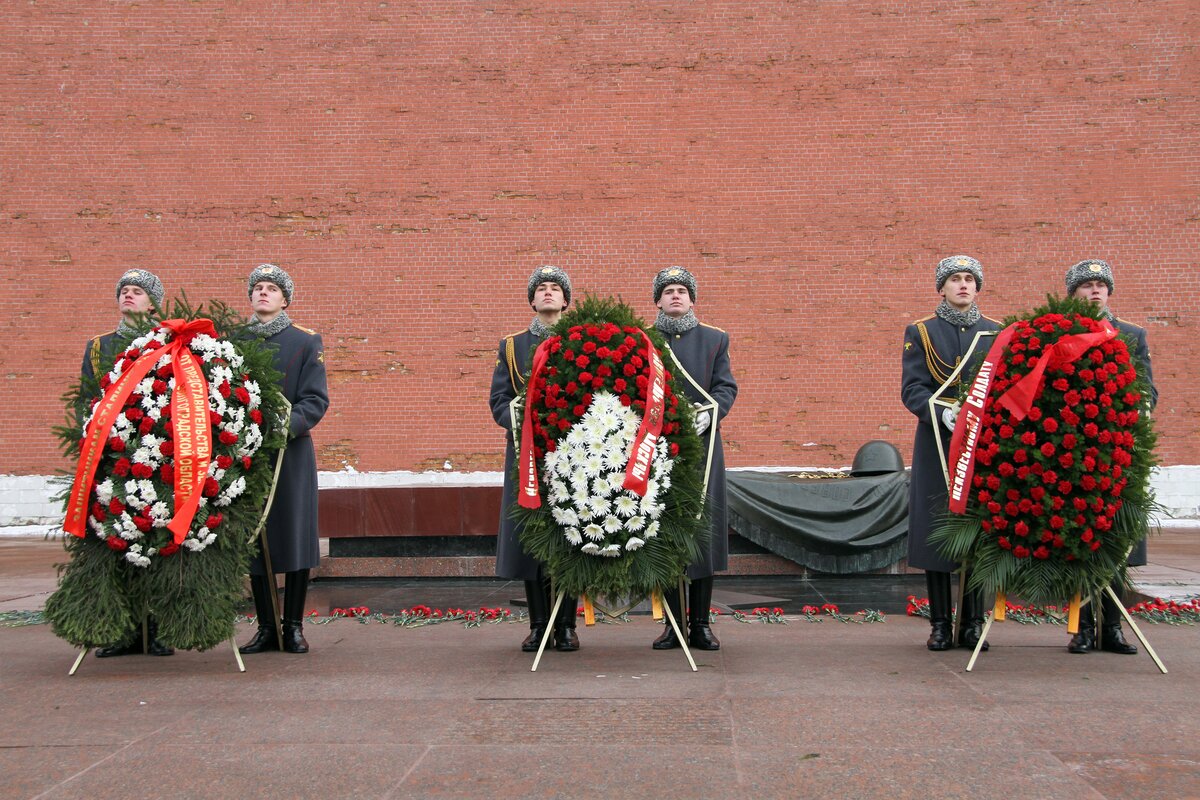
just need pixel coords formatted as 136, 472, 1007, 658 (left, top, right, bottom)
512, 297, 708, 597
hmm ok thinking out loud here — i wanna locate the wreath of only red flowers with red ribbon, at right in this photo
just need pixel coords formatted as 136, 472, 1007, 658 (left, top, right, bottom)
932, 299, 1154, 603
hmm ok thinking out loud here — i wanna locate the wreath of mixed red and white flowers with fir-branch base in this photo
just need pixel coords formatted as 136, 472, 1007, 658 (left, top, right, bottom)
46, 302, 292, 650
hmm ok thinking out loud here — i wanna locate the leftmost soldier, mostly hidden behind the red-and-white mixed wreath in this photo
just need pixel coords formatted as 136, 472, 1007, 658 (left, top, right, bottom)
79, 270, 175, 658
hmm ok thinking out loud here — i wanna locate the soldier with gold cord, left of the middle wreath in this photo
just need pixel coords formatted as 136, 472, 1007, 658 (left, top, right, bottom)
490, 266, 580, 652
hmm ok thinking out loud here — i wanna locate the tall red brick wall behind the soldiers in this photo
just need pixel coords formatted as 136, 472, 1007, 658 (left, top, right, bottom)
0, 0, 1200, 473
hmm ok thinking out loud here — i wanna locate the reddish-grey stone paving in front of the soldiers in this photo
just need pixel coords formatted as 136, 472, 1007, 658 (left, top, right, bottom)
0, 536, 1200, 800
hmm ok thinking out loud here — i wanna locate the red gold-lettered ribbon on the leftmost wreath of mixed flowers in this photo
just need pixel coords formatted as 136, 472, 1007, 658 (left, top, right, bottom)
62, 319, 217, 545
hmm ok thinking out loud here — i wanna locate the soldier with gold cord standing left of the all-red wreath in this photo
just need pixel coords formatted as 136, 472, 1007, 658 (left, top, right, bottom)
900, 255, 1000, 650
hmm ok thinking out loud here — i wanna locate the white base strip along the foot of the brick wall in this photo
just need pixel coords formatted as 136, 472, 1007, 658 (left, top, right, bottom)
0, 465, 1200, 536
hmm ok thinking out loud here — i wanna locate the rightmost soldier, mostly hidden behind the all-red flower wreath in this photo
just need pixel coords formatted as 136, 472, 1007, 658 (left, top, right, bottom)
1066, 258, 1158, 655
